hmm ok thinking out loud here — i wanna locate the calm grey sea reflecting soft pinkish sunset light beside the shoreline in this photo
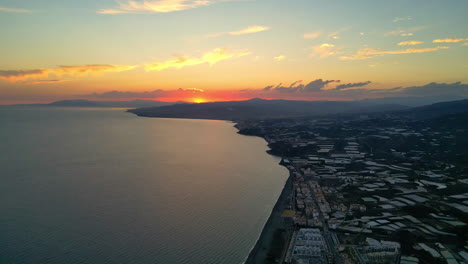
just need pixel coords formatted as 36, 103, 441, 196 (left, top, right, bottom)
0, 107, 287, 264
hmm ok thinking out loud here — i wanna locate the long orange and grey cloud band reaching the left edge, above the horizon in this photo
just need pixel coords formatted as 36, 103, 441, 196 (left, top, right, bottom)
0, 64, 136, 84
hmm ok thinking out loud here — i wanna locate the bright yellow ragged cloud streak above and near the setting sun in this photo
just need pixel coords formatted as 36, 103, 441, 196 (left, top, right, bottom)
145, 48, 251, 71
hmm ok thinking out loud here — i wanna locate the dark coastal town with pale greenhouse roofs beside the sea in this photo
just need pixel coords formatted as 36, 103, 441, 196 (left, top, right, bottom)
237, 114, 468, 264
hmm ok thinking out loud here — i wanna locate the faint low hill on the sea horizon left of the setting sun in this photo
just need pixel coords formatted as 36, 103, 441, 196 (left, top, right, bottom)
46, 100, 174, 108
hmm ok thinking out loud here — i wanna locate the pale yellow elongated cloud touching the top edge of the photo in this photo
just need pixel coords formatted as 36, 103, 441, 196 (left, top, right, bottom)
97, 0, 243, 15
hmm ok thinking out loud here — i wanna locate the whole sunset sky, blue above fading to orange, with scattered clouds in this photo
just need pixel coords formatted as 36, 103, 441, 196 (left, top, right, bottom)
0, 0, 468, 104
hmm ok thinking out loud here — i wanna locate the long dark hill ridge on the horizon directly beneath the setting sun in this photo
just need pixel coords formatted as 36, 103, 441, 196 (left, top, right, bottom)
129, 99, 407, 120
